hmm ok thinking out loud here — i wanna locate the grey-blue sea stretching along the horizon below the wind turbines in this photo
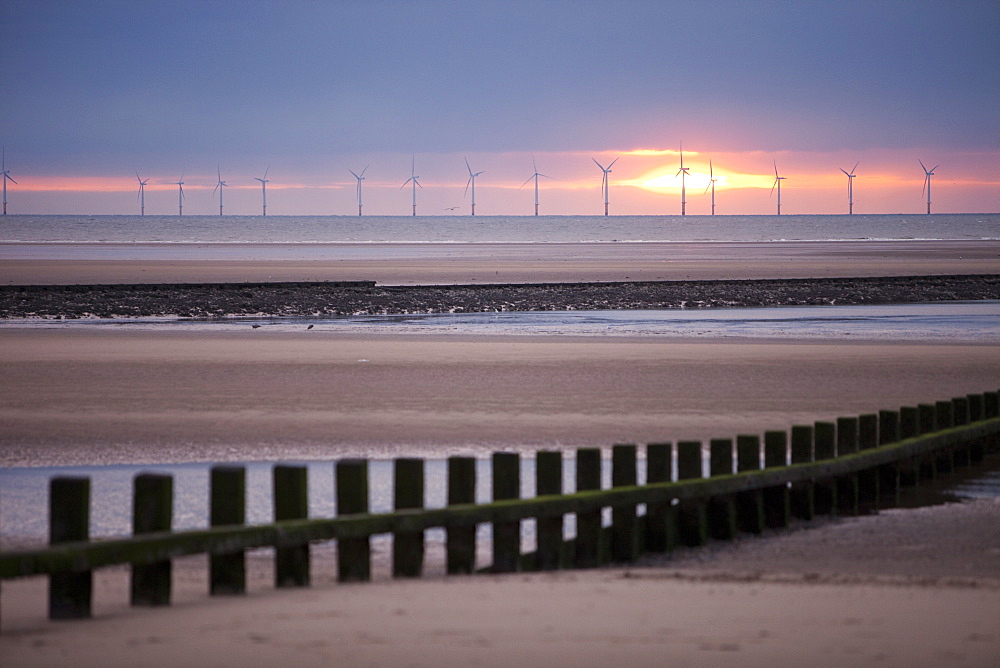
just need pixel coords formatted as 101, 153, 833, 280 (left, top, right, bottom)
0, 214, 1000, 244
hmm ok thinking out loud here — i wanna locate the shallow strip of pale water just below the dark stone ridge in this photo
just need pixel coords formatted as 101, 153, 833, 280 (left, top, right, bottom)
15, 301, 1000, 345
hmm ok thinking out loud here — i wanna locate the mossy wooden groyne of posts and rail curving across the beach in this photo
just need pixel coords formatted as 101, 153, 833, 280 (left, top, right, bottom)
0, 392, 1000, 619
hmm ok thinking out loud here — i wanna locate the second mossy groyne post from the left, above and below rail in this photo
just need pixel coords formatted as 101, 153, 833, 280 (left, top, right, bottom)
132, 473, 174, 605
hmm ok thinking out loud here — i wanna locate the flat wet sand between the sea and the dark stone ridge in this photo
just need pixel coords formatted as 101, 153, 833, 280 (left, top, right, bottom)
0, 241, 1000, 285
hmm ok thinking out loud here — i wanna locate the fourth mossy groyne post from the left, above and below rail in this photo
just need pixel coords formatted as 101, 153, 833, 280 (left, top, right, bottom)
272, 464, 309, 587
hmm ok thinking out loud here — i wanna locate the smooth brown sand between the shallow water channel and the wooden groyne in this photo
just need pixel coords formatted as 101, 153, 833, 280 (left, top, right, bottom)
0, 327, 1000, 466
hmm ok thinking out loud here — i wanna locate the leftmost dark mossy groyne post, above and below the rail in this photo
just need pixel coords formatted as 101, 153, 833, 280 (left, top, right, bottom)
49, 476, 93, 619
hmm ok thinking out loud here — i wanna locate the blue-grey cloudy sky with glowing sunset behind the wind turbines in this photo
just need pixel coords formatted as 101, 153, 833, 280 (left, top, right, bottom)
0, 0, 1000, 215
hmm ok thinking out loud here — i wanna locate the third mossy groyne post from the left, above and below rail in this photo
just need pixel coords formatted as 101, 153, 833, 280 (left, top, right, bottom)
208, 466, 247, 596
